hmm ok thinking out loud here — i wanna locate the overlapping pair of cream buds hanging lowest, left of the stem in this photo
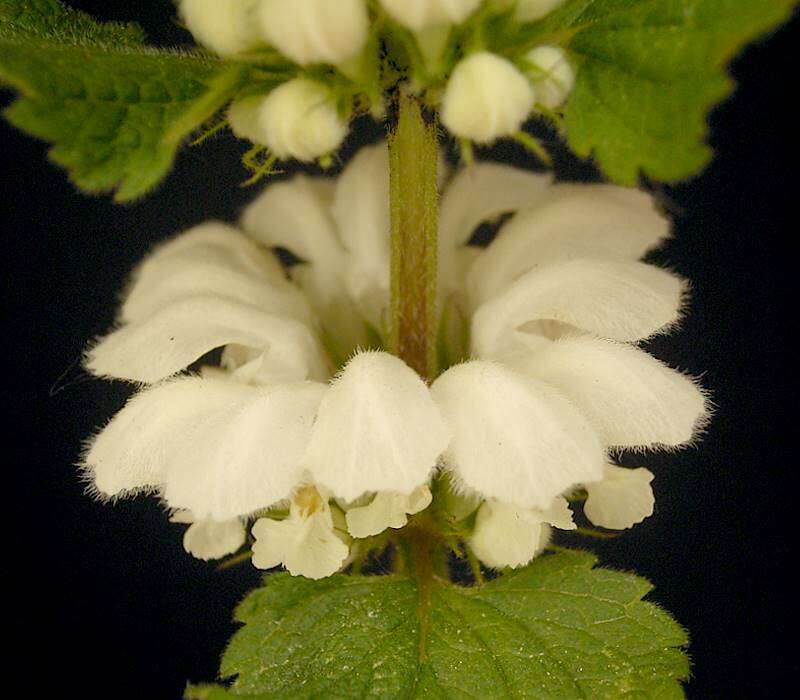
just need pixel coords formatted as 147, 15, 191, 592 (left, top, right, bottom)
228, 78, 347, 161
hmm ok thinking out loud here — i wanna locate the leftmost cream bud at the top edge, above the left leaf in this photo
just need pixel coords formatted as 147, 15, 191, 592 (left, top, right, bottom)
179, 0, 263, 56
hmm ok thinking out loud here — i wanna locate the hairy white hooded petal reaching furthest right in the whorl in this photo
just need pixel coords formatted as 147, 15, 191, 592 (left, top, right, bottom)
515, 337, 708, 447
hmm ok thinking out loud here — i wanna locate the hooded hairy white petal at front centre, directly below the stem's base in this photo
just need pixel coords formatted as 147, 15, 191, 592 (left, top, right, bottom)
307, 352, 448, 501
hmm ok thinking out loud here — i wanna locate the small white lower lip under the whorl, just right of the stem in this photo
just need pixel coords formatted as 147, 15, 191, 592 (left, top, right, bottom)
469, 498, 575, 569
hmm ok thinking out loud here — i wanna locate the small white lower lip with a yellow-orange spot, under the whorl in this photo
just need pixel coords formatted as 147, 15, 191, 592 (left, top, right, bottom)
252, 487, 350, 579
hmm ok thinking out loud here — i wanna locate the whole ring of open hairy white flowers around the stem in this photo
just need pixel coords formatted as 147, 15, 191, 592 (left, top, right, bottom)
84, 144, 707, 578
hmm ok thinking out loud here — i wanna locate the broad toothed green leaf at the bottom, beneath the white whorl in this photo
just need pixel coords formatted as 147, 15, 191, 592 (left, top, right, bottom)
217, 551, 689, 699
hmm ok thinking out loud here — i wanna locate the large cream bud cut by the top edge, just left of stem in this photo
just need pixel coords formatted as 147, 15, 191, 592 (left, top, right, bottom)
258, 0, 369, 65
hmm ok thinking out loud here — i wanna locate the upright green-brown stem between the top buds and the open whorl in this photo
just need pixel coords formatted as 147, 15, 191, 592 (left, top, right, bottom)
389, 93, 439, 380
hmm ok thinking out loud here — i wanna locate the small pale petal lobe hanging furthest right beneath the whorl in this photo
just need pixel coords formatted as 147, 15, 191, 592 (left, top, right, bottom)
583, 464, 655, 530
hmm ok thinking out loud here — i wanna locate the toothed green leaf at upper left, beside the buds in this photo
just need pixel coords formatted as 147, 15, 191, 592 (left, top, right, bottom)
0, 0, 247, 201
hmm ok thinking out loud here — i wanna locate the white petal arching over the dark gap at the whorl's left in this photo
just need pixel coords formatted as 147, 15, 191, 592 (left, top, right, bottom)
86, 297, 327, 384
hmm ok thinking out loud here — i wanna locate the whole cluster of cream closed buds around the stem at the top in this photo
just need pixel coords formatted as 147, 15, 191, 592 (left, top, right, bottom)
179, 0, 575, 161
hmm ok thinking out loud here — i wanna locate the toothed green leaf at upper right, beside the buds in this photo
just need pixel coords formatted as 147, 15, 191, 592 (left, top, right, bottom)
510, 0, 796, 185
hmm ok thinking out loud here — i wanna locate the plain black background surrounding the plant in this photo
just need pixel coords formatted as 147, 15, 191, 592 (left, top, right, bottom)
0, 0, 800, 699
